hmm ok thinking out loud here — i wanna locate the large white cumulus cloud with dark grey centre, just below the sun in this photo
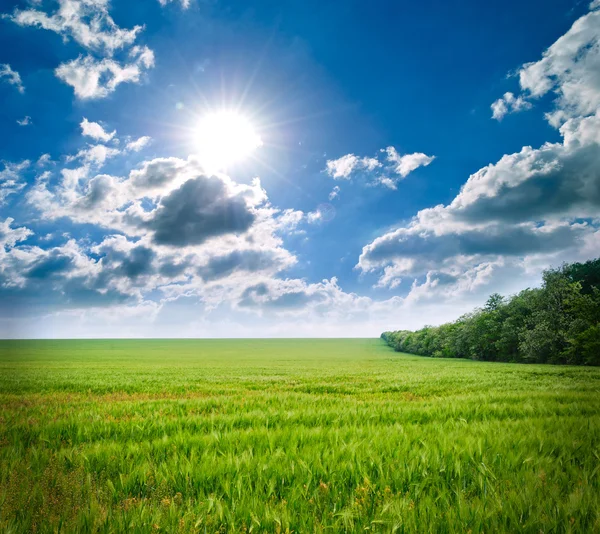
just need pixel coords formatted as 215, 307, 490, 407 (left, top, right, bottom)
18, 147, 304, 314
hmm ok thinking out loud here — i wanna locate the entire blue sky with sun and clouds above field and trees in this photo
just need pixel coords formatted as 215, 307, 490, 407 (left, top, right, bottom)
0, 0, 600, 338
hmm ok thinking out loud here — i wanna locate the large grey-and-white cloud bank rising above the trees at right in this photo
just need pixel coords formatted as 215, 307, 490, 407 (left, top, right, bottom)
357, 3, 600, 298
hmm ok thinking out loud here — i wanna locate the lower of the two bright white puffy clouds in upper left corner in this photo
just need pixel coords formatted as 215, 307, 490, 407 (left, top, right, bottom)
55, 46, 154, 100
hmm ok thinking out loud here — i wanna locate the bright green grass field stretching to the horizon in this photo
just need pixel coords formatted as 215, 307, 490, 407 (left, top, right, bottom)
0, 339, 600, 534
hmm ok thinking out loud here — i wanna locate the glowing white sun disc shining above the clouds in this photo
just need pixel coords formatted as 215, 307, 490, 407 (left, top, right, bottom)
194, 110, 263, 172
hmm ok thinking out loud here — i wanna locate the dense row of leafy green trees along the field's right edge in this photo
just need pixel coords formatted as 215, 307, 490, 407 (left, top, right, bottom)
381, 258, 600, 365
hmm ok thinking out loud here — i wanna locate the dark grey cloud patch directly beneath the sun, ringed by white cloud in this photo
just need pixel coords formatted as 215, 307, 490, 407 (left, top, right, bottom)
145, 176, 255, 247
